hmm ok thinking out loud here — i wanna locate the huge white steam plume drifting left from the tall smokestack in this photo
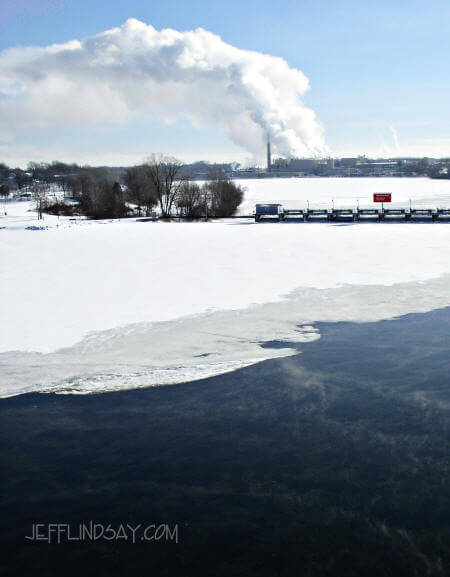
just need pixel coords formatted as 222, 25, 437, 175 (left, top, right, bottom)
0, 19, 328, 157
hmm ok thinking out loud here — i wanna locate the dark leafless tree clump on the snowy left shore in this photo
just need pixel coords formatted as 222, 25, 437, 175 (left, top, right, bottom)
0, 155, 244, 219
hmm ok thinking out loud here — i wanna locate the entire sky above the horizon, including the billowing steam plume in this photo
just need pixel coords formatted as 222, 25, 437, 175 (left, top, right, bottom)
0, 0, 450, 166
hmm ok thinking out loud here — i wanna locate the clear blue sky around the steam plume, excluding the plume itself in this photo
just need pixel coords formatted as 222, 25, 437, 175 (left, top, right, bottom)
0, 0, 450, 162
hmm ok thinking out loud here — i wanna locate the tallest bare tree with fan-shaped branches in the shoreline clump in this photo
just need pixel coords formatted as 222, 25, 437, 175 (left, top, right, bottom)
144, 154, 182, 217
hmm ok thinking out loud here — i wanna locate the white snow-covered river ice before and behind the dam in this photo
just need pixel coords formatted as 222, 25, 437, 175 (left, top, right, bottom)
0, 179, 450, 396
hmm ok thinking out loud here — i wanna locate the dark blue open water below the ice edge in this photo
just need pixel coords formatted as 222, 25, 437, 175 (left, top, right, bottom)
0, 309, 450, 577
